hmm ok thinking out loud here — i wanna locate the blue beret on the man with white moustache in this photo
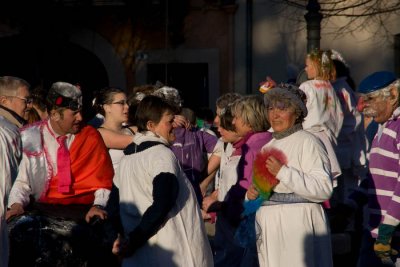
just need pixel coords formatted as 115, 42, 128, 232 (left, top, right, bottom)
358, 71, 397, 94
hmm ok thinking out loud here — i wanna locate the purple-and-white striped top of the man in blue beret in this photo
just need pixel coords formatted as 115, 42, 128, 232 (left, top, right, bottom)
368, 108, 400, 237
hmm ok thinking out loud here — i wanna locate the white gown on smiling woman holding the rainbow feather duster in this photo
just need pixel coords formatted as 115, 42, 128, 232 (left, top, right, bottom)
256, 130, 332, 267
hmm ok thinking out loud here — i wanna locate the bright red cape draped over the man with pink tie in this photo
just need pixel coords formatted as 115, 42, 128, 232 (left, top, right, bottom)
42, 126, 114, 205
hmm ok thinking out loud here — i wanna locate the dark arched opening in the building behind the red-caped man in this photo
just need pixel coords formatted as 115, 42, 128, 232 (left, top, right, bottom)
0, 35, 109, 120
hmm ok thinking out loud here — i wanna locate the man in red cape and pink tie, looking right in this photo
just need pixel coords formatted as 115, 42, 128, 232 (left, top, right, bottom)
6, 82, 114, 263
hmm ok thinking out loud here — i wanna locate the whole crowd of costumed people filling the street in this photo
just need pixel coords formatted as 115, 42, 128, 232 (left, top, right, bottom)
0, 49, 400, 267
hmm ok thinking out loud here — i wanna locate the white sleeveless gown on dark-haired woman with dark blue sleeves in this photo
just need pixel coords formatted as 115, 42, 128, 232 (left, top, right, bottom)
114, 132, 213, 267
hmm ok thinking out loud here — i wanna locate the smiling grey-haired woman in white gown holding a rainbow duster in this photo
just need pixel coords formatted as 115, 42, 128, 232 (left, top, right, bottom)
247, 84, 332, 267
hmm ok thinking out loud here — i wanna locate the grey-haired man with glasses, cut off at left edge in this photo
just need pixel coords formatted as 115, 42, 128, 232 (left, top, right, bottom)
0, 76, 30, 267
